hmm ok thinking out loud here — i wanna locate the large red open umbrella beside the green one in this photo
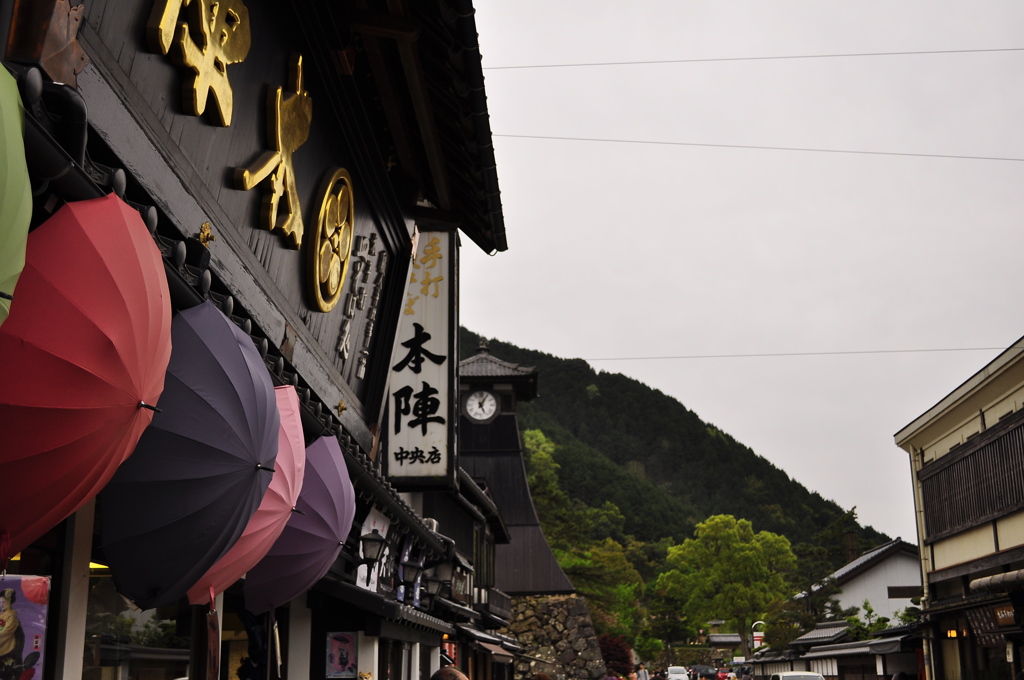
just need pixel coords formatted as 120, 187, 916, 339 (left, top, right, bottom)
0, 194, 171, 554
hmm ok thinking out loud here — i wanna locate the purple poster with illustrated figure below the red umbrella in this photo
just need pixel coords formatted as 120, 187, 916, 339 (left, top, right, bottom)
0, 573, 50, 680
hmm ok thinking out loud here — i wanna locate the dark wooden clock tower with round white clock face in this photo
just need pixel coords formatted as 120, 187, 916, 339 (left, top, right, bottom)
459, 341, 574, 596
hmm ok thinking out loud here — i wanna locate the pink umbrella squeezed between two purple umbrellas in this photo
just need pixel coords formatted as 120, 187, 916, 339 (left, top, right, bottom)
188, 385, 306, 604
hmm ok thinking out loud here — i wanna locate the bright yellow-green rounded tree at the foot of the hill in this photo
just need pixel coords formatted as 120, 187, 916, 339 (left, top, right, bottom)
656, 515, 797, 656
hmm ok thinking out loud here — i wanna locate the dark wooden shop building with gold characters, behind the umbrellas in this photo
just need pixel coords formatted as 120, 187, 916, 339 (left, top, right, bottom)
0, 0, 509, 680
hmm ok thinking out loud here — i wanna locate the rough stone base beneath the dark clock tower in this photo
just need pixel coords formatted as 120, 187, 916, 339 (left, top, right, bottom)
502, 595, 604, 680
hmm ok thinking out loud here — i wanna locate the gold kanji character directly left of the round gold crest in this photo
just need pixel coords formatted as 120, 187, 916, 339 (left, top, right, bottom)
234, 54, 313, 248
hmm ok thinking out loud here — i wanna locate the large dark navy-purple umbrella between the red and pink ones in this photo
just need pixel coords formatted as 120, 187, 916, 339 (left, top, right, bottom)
99, 302, 280, 609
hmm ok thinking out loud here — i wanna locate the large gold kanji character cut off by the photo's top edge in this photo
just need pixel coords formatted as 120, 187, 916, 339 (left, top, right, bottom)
146, 0, 252, 126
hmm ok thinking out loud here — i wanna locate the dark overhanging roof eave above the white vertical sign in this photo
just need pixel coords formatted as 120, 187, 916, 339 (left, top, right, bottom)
351, 0, 507, 252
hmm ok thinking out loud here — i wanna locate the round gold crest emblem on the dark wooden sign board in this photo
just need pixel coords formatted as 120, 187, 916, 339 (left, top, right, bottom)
306, 168, 355, 311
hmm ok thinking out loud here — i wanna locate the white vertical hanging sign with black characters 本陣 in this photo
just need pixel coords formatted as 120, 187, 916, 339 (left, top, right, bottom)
386, 231, 459, 488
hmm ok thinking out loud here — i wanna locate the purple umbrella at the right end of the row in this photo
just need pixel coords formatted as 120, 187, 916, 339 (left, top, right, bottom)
245, 436, 355, 613
